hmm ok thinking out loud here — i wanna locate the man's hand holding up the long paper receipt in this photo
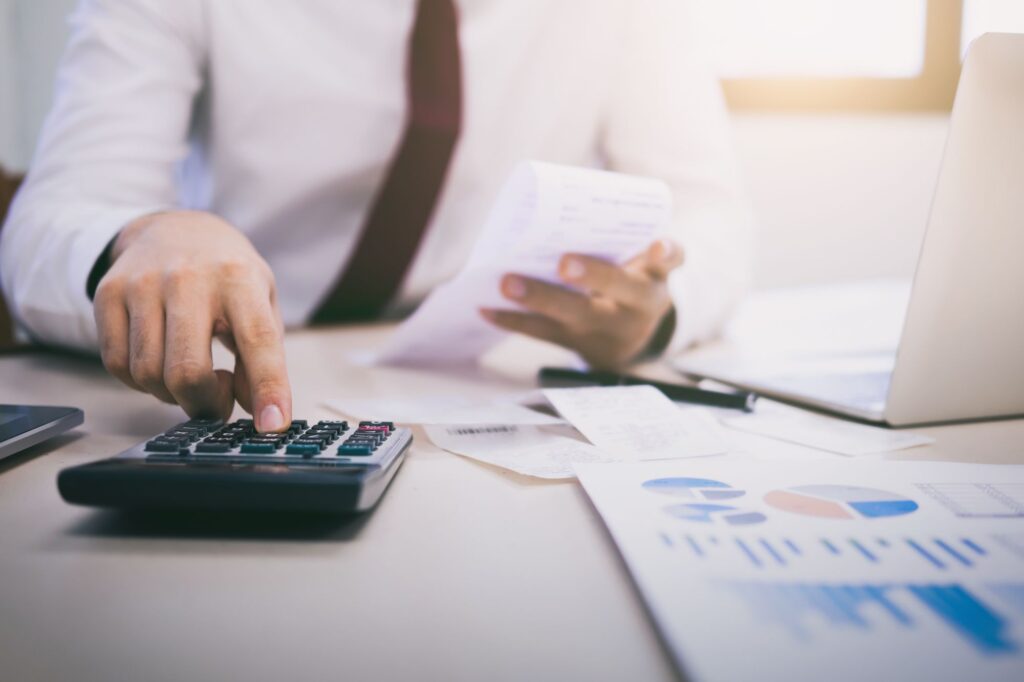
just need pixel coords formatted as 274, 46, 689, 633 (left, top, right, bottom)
480, 240, 683, 368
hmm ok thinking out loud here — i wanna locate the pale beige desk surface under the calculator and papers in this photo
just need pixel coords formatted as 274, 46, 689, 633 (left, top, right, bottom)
0, 327, 1024, 682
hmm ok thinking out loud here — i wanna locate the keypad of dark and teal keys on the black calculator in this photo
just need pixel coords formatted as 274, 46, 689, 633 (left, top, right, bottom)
142, 419, 395, 466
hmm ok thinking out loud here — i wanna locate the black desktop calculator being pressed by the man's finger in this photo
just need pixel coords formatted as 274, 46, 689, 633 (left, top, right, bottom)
57, 419, 413, 513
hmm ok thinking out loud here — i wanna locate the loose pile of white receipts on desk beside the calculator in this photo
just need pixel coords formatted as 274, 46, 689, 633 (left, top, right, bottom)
329, 386, 728, 478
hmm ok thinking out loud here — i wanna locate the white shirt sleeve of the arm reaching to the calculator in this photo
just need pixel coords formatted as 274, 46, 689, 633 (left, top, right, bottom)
0, 0, 205, 350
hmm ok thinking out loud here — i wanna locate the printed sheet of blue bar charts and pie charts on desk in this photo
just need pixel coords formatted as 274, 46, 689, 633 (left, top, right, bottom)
577, 458, 1024, 682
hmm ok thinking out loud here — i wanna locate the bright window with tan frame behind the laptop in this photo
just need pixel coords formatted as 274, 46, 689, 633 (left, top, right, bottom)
699, 0, 1024, 111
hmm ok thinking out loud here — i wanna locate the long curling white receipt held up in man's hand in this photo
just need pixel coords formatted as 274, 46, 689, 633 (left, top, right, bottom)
378, 162, 672, 366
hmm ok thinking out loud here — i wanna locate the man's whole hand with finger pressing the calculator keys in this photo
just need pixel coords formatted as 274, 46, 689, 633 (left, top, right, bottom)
94, 211, 292, 431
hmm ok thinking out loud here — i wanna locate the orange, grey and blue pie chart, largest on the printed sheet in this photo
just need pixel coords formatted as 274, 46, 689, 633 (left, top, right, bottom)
765, 485, 918, 519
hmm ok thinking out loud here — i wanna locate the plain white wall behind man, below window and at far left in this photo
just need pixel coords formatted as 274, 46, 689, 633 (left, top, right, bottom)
0, 0, 946, 287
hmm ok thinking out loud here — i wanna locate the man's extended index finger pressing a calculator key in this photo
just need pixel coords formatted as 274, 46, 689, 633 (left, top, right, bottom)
224, 287, 292, 432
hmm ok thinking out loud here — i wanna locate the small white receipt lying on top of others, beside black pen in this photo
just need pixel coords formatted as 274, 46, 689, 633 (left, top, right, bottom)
544, 386, 728, 460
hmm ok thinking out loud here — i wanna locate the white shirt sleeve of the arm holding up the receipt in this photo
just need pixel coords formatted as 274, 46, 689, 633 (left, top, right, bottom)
602, 0, 754, 350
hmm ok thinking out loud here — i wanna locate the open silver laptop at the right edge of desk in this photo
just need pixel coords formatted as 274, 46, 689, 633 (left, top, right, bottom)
676, 34, 1024, 427
